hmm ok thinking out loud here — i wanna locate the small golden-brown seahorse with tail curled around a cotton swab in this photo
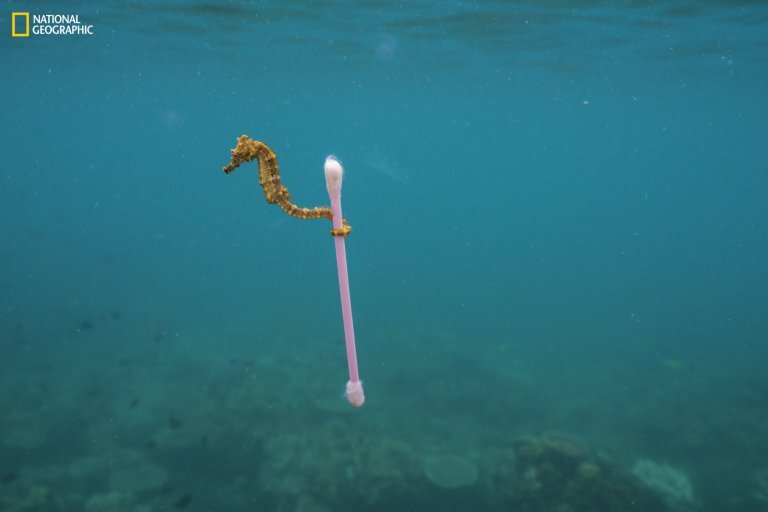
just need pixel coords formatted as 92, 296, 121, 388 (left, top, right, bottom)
223, 135, 352, 236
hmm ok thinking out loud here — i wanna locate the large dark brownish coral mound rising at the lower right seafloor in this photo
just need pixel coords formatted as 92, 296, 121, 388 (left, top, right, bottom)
497, 434, 668, 512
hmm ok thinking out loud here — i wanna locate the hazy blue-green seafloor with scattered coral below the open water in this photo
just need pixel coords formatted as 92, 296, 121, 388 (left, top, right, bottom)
0, 311, 768, 512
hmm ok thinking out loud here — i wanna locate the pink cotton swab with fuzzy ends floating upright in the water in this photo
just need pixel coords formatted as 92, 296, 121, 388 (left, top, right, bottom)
325, 155, 365, 407
